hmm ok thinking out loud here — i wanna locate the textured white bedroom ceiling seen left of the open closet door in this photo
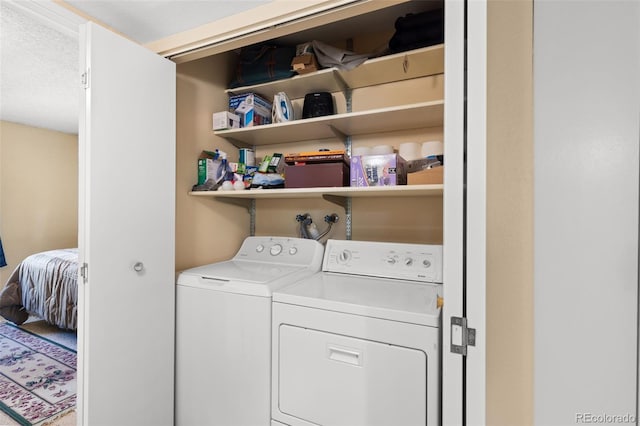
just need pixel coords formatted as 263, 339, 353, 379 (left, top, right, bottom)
0, 1, 79, 133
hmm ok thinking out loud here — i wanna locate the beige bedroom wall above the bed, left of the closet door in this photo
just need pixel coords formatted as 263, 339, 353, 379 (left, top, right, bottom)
0, 121, 78, 286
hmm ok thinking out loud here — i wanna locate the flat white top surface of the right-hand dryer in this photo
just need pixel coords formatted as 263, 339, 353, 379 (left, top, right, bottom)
273, 272, 442, 327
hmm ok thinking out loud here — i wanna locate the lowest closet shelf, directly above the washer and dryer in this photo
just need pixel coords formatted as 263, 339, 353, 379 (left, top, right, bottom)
189, 185, 443, 200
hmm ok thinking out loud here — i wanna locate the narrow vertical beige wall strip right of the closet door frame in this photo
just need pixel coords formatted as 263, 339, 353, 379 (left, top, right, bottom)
486, 0, 533, 426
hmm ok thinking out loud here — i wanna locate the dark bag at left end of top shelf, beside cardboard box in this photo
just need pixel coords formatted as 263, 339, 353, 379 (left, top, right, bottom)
229, 44, 296, 89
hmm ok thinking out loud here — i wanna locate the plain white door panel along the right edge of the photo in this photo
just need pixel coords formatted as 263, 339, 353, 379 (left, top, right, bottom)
534, 0, 640, 425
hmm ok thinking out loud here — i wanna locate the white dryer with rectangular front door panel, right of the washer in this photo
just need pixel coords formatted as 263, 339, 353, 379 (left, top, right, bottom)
271, 240, 442, 426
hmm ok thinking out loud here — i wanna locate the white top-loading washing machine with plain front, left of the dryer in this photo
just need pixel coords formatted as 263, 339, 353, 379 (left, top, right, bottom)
175, 237, 324, 426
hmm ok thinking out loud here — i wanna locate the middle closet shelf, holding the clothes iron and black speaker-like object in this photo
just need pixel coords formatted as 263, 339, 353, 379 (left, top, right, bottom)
214, 100, 444, 146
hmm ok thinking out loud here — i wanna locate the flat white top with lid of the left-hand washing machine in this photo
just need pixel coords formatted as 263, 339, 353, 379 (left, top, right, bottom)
178, 260, 318, 297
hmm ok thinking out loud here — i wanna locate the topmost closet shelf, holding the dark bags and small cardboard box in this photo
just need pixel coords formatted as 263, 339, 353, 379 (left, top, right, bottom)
226, 44, 444, 99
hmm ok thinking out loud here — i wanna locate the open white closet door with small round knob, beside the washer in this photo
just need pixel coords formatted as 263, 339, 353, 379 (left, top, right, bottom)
78, 24, 176, 426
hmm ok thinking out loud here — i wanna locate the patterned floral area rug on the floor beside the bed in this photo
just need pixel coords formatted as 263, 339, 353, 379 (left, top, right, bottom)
0, 323, 76, 426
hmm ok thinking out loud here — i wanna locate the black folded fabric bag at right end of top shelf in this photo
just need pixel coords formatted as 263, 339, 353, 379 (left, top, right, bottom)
389, 9, 444, 53
